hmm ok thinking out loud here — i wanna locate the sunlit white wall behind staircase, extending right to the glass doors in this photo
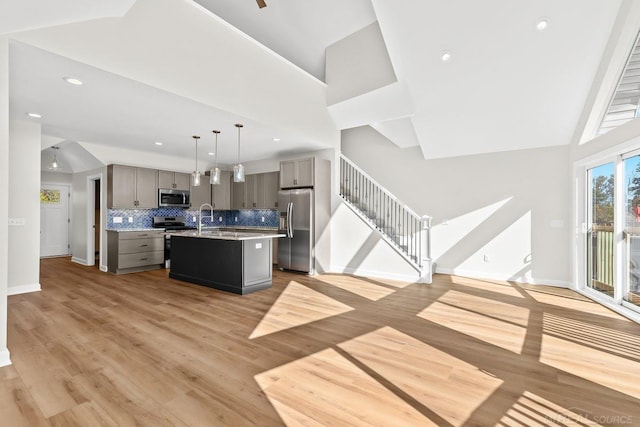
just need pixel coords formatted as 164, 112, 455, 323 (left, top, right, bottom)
342, 127, 571, 285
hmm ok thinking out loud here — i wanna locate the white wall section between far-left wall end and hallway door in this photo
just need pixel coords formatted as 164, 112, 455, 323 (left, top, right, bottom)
8, 118, 40, 295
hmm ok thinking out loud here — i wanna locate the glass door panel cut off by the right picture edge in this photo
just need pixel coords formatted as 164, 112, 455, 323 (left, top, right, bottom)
622, 155, 640, 307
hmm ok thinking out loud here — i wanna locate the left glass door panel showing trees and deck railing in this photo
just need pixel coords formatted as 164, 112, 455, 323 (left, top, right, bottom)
586, 163, 615, 297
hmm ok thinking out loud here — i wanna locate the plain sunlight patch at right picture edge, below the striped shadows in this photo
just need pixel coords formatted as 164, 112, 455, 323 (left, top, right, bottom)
540, 315, 640, 399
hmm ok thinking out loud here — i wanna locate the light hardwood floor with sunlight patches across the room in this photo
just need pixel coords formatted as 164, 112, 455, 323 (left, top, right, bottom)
0, 258, 640, 426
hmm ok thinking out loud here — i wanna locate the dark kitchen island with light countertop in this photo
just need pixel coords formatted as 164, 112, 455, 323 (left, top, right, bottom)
169, 230, 285, 295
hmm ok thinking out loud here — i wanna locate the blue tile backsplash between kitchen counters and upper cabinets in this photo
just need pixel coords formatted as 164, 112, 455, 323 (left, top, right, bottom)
107, 207, 279, 230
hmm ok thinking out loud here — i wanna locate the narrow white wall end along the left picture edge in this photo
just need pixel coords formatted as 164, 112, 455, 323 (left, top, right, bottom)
0, 37, 11, 366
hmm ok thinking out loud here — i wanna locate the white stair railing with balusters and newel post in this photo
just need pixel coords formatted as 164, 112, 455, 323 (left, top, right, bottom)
340, 155, 432, 283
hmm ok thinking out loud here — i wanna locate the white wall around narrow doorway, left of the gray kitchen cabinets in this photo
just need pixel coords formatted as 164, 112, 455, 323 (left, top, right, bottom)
71, 167, 107, 270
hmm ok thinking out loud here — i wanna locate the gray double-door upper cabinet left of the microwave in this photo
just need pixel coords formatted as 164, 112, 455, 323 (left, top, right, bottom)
107, 165, 158, 209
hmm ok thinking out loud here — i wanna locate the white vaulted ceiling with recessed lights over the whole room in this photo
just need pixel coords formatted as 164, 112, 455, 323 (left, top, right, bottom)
0, 0, 623, 171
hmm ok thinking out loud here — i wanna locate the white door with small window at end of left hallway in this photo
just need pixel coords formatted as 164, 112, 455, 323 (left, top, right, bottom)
40, 184, 70, 257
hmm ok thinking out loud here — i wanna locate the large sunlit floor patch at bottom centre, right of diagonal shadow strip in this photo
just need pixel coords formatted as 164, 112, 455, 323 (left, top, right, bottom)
339, 327, 503, 426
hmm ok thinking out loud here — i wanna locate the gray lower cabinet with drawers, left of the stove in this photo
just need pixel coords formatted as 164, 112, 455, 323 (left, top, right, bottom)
107, 230, 164, 274
